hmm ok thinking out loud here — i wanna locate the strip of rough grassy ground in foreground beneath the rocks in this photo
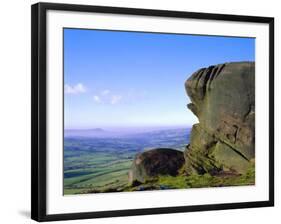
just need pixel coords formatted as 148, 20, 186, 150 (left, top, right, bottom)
66, 160, 255, 194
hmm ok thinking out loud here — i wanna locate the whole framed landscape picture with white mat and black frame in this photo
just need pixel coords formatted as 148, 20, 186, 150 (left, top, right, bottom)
31, 3, 274, 221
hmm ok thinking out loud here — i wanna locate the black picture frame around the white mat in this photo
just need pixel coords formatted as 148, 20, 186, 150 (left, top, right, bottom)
31, 3, 274, 221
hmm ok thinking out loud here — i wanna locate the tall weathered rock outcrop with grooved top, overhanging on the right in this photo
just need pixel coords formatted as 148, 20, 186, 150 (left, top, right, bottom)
184, 62, 255, 174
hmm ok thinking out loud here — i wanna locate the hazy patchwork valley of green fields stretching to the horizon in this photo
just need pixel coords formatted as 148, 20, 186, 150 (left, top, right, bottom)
64, 128, 190, 195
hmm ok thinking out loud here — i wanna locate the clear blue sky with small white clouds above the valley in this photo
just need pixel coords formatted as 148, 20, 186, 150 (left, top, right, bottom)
64, 29, 255, 128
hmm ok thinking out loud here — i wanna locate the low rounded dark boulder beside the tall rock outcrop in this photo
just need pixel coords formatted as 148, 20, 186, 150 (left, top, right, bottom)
129, 148, 184, 185
